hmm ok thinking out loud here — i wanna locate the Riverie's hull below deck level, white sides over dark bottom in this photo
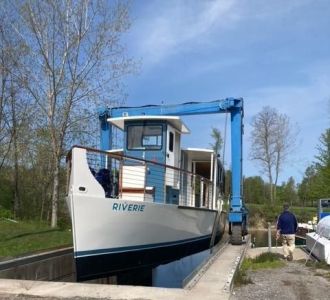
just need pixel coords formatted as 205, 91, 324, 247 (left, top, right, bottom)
68, 195, 224, 281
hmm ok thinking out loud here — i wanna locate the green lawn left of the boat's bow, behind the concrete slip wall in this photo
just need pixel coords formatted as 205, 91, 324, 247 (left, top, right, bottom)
0, 219, 72, 260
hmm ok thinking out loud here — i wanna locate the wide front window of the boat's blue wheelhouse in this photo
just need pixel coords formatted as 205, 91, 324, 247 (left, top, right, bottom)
127, 125, 163, 150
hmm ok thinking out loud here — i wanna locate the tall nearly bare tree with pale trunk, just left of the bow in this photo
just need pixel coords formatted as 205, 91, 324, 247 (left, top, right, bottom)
8, 0, 135, 226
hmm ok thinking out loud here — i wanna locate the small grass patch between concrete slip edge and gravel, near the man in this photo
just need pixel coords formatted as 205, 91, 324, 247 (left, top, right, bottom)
234, 252, 285, 286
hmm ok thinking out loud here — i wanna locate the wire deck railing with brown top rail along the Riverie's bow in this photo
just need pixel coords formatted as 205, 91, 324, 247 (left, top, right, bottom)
67, 146, 216, 209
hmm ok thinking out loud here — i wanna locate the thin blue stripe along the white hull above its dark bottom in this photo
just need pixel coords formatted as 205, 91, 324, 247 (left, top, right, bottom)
74, 234, 211, 257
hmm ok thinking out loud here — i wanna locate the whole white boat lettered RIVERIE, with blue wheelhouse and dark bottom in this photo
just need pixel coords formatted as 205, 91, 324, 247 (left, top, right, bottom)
67, 116, 226, 281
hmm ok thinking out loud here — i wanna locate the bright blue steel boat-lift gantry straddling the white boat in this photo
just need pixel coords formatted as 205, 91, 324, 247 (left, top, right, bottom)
99, 98, 248, 245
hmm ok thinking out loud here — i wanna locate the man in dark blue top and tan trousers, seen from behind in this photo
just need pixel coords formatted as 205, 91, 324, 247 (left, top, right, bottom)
276, 204, 298, 261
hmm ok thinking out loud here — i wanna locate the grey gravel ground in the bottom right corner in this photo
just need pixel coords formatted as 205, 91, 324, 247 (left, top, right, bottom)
230, 262, 330, 300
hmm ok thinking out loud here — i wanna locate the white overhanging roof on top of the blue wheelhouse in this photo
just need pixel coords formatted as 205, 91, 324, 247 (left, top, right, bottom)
107, 116, 190, 133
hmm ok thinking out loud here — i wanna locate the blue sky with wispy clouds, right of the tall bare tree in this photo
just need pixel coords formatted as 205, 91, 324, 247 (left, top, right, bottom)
124, 0, 330, 183
